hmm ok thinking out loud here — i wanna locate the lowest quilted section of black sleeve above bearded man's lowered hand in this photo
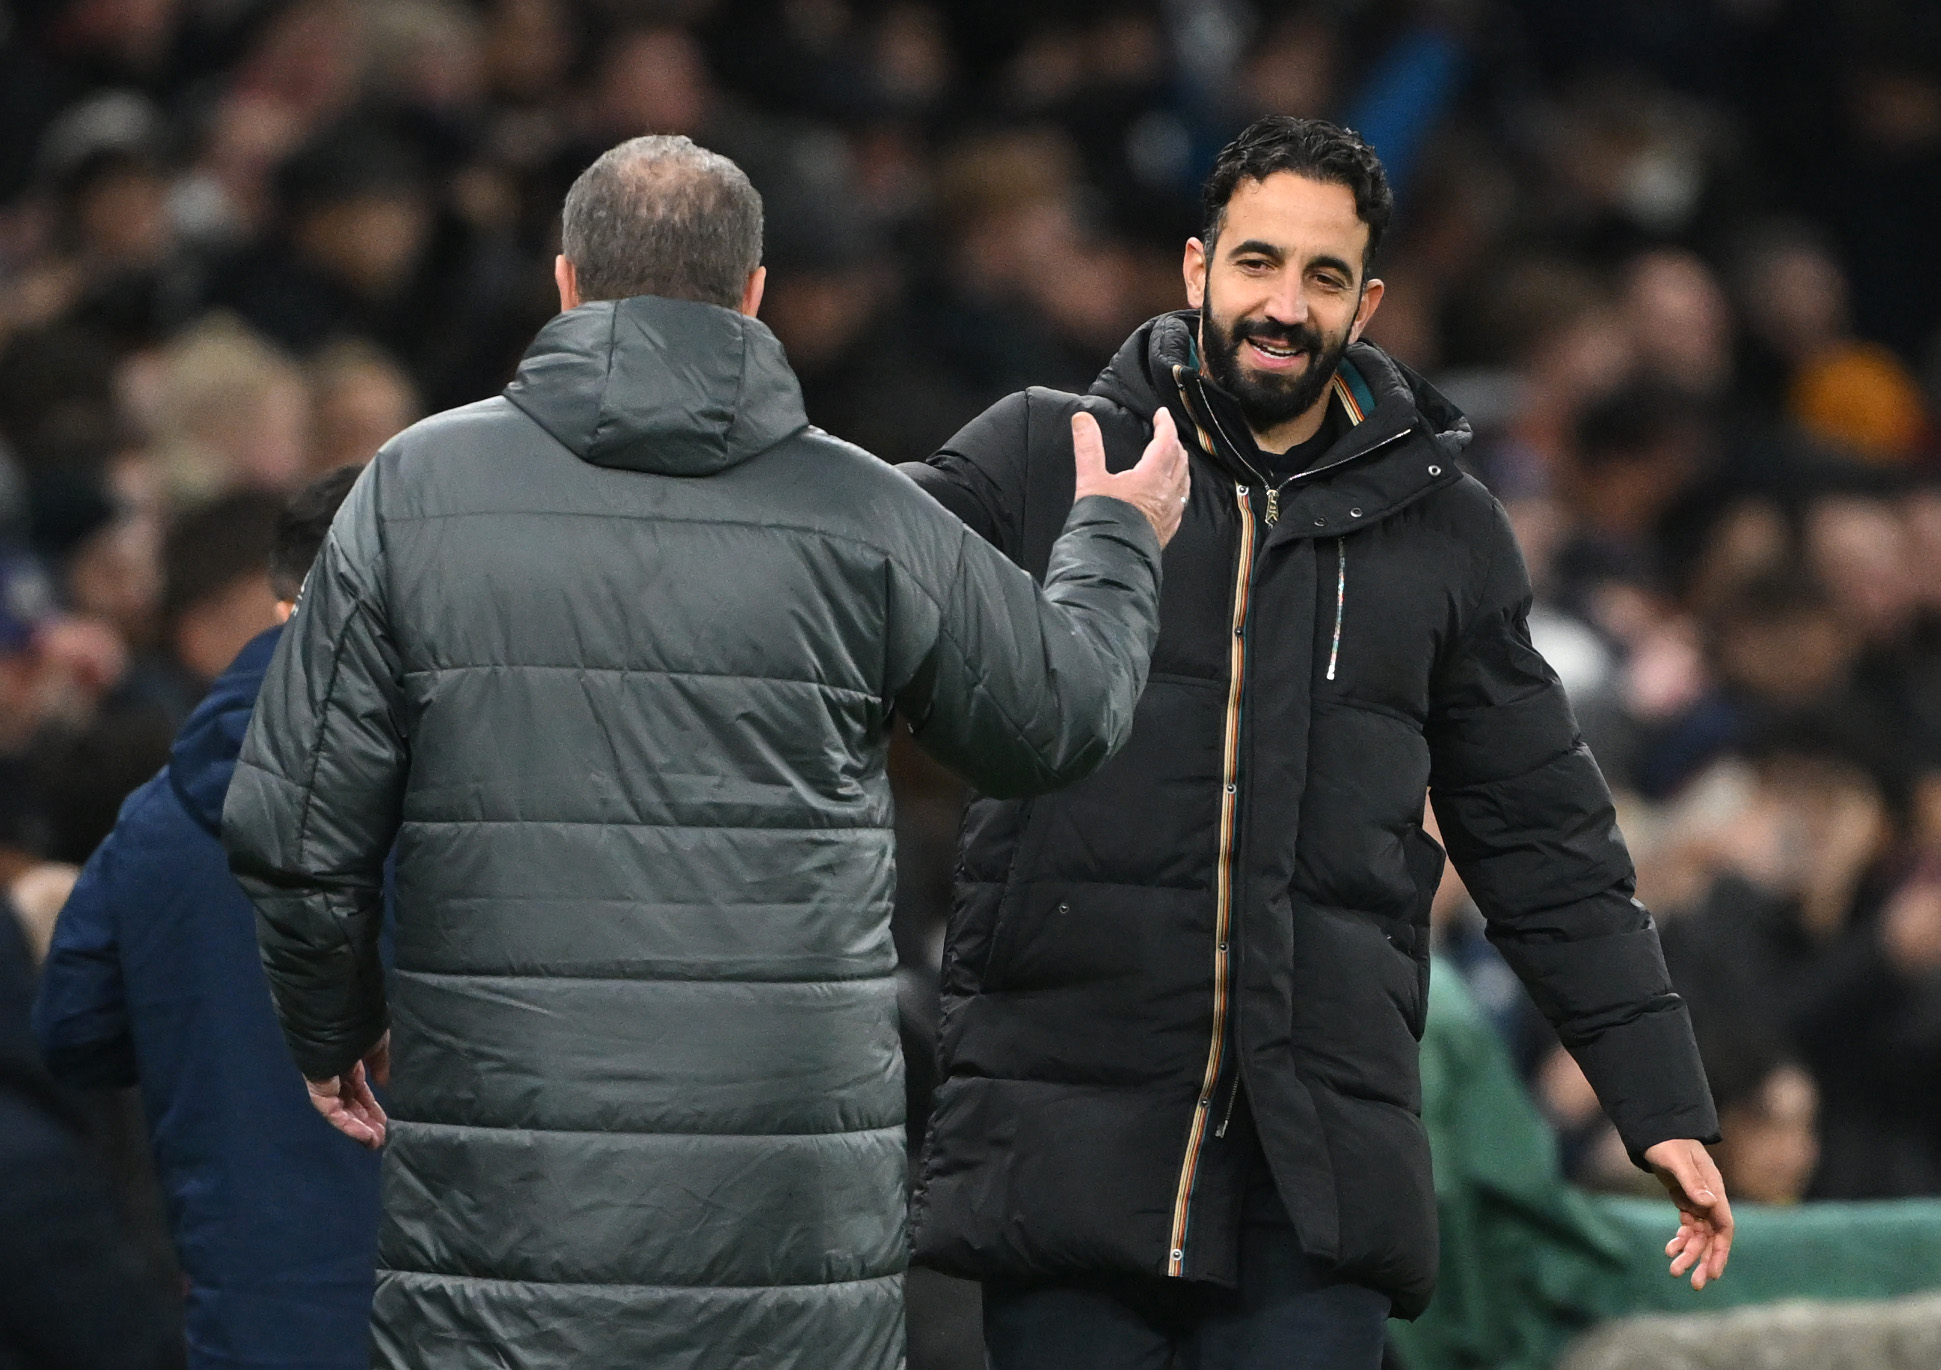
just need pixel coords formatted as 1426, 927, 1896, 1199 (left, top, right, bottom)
1572, 999, 1718, 1168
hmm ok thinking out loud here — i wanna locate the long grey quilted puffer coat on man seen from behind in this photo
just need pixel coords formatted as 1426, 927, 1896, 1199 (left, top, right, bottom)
225, 297, 1159, 1370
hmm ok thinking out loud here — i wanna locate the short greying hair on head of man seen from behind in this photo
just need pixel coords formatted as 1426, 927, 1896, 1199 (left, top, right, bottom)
559, 134, 761, 309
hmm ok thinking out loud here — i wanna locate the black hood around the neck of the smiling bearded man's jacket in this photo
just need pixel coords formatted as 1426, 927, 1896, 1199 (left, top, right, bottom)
1091, 309, 1471, 485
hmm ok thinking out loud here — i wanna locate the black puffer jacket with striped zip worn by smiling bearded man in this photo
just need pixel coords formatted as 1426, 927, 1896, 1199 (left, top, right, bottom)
905, 314, 1716, 1316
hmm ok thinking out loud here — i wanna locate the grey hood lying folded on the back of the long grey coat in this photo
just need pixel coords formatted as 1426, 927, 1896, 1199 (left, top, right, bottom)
505, 295, 809, 475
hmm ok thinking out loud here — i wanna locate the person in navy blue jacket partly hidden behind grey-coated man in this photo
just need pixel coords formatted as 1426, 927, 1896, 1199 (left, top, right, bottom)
33, 468, 378, 1370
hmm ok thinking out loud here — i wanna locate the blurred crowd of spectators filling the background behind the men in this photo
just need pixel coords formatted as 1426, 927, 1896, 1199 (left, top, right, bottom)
0, 0, 1941, 1335
